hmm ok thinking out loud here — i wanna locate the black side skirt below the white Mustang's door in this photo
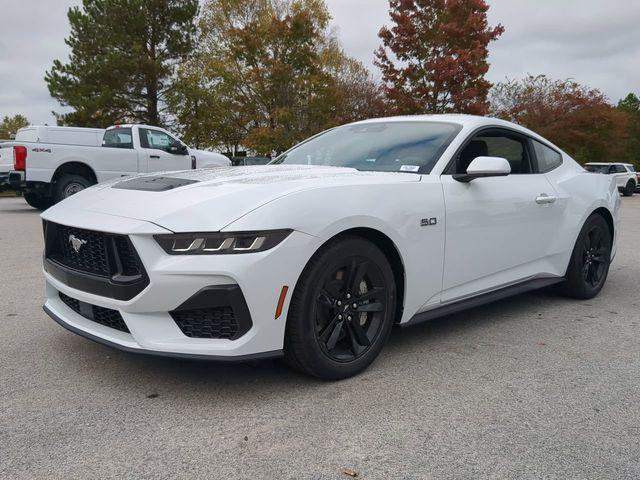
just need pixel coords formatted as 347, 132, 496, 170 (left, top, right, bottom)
400, 277, 564, 328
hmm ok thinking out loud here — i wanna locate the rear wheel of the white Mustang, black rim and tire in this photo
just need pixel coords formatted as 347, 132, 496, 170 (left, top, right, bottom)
561, 214, 612, 300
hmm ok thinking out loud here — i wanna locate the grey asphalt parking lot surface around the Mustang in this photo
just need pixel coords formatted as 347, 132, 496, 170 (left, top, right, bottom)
0, 195, 640, 479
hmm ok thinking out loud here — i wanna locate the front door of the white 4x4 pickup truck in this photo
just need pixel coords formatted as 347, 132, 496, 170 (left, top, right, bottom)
139, 128, 191, 172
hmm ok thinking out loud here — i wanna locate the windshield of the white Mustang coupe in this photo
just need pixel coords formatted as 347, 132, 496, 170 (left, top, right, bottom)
272, 122, 462, 173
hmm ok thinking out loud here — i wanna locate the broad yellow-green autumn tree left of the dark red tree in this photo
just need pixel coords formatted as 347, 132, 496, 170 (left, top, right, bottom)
169, 0, 380, 154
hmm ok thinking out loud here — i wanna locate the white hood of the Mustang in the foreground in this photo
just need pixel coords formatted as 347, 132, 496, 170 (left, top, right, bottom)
43, 165, 421, 232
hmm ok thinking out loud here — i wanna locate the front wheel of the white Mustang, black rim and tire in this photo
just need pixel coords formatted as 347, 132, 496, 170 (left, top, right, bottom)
284, 236, 396, 380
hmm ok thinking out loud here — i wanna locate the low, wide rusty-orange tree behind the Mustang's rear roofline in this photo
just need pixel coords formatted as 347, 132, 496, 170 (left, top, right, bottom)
491, 75, 629, 163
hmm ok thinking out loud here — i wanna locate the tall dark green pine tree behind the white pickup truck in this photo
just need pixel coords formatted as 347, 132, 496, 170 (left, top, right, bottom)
45, 0, 198, 127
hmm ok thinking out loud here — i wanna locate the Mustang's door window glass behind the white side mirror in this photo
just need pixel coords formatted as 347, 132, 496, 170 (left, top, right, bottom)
456, 130, 532, 175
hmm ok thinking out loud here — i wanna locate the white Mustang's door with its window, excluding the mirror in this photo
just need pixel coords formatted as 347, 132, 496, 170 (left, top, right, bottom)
441, 128, 562, 302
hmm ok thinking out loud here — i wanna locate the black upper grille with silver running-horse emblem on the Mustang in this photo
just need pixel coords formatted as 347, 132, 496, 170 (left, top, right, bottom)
45, 222, 145, 281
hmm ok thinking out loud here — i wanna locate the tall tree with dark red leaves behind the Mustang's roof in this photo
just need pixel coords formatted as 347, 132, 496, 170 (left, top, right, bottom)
375, 0, 504, 115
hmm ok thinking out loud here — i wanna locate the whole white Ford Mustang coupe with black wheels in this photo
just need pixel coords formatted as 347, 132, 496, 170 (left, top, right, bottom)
42, 115, 620, 379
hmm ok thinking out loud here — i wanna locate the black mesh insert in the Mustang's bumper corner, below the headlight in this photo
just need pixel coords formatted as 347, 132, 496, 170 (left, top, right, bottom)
171, 307, 239, 340
